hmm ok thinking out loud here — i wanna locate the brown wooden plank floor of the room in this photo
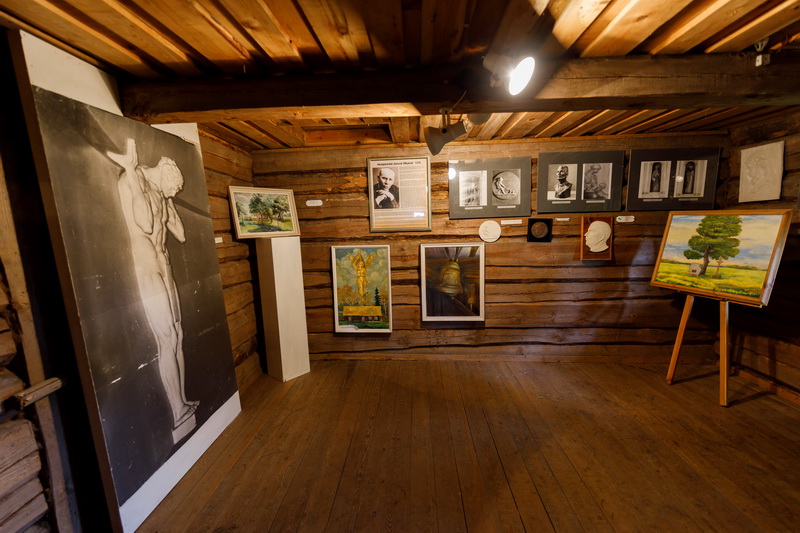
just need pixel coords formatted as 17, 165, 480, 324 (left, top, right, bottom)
141, 361, 800, 533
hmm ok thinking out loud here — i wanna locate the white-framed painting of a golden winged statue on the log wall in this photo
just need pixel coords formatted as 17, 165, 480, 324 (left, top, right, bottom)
331, 245, 392, 333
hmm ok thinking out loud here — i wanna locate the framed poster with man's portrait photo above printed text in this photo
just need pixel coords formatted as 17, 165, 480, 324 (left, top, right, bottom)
367, 157, 431, 232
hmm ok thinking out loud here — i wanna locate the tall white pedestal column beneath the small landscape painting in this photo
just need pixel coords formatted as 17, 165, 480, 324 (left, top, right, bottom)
256, 237, 311, 381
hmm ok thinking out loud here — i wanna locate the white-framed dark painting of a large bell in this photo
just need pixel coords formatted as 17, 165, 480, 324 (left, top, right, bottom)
420, 242, 484, 322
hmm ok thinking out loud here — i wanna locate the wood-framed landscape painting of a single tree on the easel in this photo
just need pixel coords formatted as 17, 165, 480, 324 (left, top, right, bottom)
651, 210, 791, 306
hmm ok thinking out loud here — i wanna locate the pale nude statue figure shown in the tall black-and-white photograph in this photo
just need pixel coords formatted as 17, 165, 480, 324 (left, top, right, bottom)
107, 139, 200, 430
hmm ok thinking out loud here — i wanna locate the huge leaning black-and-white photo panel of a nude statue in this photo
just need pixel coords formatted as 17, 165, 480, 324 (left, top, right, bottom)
25, 87, 239, 530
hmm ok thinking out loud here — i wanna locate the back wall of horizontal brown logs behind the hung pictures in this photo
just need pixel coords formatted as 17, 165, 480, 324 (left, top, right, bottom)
253, 136, 728, 362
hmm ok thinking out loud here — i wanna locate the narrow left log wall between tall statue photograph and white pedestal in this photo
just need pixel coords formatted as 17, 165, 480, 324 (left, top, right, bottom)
200, 128, 261, 389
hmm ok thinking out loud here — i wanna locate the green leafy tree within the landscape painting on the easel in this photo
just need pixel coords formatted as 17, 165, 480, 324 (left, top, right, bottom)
683, 215, 742, 278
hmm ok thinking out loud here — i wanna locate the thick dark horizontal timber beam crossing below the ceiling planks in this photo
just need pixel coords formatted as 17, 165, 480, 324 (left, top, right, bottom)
122, 51, 800, 123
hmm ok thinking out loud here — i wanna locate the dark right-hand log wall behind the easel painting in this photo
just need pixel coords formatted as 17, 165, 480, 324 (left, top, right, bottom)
717, 113, 800, 401
